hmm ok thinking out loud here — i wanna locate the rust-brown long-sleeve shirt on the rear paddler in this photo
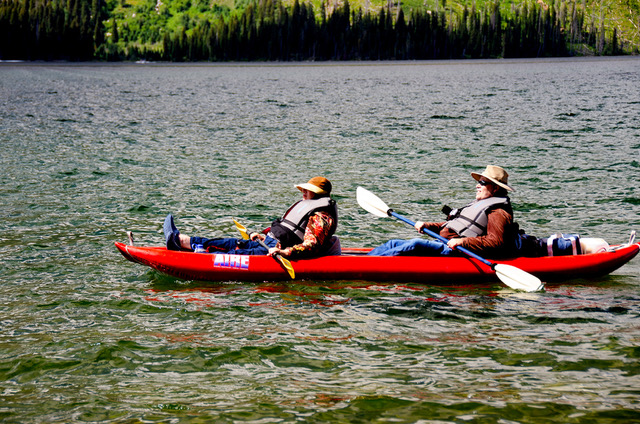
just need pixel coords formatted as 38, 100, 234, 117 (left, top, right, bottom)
425, 209, 513, 257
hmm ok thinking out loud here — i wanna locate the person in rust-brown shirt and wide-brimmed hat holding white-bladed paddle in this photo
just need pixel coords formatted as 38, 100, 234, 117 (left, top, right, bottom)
369, 165, 517, 258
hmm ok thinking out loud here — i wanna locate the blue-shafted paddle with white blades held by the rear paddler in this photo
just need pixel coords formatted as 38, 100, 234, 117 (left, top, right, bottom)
356, 187, 544, 292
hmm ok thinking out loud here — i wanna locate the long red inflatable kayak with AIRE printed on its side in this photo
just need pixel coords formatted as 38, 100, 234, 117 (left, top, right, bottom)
115, 242, 640, 283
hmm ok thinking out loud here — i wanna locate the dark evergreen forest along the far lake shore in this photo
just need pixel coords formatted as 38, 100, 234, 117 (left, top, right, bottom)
0, 0, 638, 62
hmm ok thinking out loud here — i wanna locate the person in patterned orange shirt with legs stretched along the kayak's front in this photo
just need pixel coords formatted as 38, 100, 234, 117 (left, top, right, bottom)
164, 177, 340, 258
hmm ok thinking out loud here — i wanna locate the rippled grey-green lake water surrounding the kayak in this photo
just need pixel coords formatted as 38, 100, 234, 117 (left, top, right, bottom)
0, 57, 640, 423
